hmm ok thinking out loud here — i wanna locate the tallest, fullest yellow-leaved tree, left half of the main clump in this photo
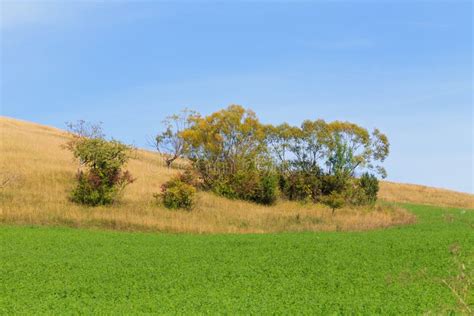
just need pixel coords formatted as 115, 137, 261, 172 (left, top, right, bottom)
181, 105, 278, 204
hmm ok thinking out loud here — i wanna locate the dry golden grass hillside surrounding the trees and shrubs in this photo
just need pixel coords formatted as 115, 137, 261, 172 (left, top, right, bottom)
0, 117, 473, 233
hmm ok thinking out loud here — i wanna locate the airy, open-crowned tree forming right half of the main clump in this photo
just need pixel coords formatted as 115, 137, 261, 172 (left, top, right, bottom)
266, 120, 389, 202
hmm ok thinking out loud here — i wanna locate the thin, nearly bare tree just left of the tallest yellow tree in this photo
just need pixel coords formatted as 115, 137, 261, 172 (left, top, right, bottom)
153, 109, 196, 168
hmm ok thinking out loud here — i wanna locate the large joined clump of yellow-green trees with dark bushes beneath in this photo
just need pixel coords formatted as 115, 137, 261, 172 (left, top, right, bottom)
156, 105, 389, 209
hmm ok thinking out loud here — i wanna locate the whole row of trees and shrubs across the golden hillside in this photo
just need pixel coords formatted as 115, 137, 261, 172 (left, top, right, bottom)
65, 105, 389, 211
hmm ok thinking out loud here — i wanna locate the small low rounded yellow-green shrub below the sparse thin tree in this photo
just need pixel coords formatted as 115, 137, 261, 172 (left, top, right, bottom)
156, 178, 196, 210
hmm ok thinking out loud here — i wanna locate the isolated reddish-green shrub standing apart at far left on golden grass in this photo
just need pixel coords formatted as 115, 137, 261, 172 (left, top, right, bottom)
67, 137, 134, 206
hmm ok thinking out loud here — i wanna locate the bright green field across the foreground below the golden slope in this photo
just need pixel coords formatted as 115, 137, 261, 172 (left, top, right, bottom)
0, 205, 474, 314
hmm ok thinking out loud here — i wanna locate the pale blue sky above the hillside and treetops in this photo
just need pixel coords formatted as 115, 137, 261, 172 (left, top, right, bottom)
0, 0, 474, 193
